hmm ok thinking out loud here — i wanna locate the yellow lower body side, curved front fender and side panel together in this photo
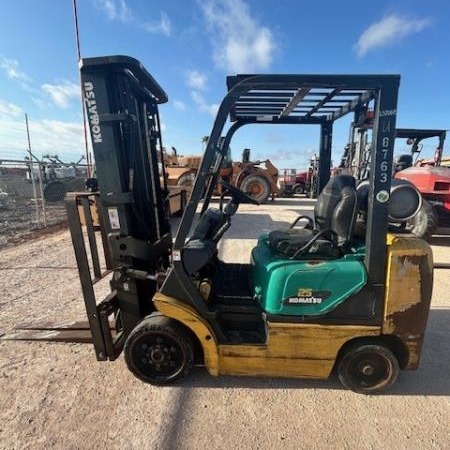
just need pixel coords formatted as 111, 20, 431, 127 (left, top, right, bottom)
153, 293, 380, 378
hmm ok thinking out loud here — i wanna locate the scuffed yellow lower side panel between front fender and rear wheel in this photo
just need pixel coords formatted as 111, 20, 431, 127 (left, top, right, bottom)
219, 322, 381, 378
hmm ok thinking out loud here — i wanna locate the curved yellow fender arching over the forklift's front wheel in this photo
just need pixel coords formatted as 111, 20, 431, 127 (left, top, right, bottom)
153, 292, 218, 375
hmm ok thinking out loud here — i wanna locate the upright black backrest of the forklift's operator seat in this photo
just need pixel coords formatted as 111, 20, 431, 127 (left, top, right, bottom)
314, 175, 357, 248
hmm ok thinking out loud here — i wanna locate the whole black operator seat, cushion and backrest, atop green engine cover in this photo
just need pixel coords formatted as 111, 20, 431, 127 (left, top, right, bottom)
268, 175, 357, 259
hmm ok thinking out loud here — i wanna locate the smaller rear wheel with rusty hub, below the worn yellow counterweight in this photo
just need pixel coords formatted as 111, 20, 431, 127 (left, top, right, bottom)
337, 343, 399, 394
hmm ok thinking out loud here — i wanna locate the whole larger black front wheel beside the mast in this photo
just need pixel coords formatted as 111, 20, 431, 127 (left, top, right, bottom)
124, 315, 194, 385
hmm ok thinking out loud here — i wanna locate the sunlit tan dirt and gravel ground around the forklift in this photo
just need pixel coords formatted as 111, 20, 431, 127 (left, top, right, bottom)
0, 199, 450, 450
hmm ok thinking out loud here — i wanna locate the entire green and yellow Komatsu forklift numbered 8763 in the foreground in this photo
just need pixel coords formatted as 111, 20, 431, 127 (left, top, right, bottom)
14, 56, 432, 393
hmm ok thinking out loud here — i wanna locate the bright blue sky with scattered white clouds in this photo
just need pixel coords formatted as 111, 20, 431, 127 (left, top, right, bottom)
0, 0, 450, 168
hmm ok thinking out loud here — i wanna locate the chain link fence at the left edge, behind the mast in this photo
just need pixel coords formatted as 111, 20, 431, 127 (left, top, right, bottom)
0, 159, 87, 247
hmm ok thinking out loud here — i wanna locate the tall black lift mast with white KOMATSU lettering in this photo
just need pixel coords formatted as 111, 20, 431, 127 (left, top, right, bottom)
77, 56, 172, 344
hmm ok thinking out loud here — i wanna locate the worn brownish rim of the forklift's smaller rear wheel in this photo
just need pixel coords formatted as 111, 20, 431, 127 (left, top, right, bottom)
346, 352, 394, 390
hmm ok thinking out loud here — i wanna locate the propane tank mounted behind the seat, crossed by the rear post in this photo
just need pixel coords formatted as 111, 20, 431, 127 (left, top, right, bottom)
356, 178, 422, 223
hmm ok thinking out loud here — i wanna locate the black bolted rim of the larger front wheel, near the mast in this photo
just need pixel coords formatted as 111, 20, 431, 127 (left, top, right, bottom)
132, 333, 185, 381
